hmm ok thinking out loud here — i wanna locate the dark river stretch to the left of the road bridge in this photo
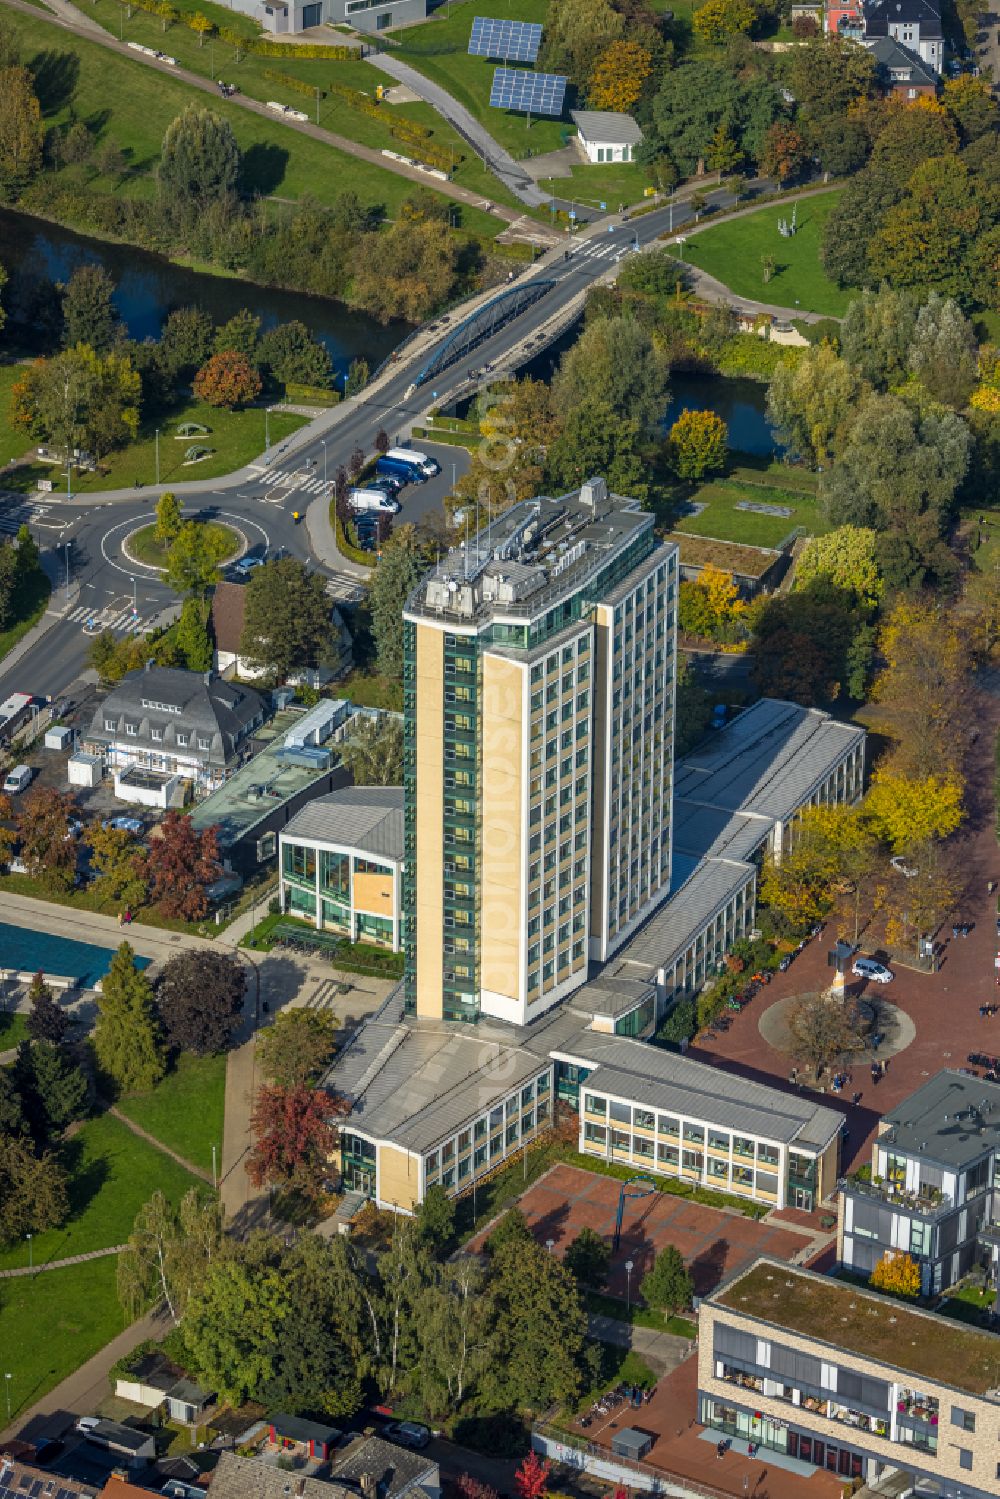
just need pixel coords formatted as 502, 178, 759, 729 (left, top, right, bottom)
0, 210, 409, 373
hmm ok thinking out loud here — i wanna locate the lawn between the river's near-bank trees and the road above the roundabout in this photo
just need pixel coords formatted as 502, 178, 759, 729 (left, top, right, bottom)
3, 399, 306, 493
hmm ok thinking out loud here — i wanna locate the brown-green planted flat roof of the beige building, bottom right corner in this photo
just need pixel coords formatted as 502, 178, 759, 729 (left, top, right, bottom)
708, 1259, 1000, 1414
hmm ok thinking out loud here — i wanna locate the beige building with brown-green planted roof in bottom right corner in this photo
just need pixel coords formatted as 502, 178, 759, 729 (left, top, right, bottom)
699, 1259, 1000, 1499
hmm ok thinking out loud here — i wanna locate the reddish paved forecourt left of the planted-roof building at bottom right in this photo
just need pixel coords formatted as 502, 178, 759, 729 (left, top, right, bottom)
569, 1357, 841, 1499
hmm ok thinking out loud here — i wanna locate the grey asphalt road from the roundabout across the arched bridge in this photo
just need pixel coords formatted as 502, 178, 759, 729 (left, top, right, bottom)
0, 183, 771, 696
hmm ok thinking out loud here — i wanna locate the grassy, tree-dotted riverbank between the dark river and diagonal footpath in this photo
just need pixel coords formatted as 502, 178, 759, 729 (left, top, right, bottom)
0, 13, 512, 321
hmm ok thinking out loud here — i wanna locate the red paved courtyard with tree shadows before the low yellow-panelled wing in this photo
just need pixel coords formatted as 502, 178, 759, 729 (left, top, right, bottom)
472, 1165, 814, 1297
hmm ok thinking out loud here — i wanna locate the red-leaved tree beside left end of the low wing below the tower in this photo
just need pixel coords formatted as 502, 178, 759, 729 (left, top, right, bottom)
246, 1084, 349, 1196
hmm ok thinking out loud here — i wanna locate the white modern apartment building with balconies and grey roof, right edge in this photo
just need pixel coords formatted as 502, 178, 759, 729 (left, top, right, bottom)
837, 1070, 1000, 1295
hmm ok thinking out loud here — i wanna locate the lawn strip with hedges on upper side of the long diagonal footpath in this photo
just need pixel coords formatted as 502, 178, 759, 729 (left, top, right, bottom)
84, 0, 516, 214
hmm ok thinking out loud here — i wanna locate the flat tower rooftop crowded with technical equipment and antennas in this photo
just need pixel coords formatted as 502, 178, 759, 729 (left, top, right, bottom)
405, 477, 655, 627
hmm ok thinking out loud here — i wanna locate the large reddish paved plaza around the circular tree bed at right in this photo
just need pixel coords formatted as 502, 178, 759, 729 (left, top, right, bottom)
690, 680, 1000, 1181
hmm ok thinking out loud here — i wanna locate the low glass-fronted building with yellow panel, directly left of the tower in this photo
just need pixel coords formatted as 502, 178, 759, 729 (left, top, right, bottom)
279, 785, 403, 952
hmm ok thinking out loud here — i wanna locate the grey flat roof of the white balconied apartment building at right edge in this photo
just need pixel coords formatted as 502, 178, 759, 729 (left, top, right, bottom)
876, 1069, 1000, 1169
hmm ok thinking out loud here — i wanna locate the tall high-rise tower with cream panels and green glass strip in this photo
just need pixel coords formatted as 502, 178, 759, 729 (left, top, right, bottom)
403, 478, 678, 1024
